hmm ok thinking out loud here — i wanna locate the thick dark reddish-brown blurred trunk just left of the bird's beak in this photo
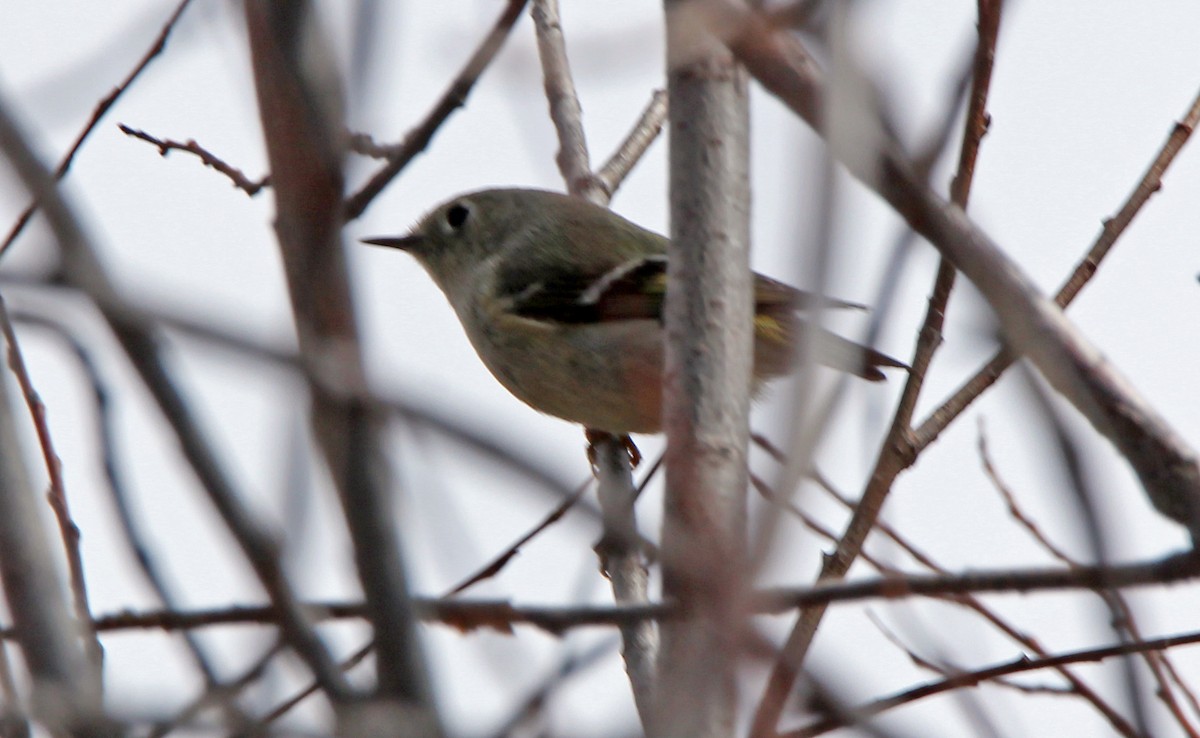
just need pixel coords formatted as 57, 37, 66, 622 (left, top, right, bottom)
245, 0, 439, 734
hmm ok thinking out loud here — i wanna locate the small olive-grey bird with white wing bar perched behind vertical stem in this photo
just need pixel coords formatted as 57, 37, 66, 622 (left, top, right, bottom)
364, 190, 905, 434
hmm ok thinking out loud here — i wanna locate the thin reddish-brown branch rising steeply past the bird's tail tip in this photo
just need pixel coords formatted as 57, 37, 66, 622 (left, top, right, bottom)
753, 0, 1002, 737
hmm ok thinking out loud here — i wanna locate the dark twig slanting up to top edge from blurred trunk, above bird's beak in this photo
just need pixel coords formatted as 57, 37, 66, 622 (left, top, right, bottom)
344, 0, 527, 221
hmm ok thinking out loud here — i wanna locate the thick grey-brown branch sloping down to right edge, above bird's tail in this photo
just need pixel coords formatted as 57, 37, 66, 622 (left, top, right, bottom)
724, 4, 1200, 538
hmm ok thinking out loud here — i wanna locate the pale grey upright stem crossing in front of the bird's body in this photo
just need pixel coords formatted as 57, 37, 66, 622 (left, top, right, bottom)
653, 0, 754, 736
